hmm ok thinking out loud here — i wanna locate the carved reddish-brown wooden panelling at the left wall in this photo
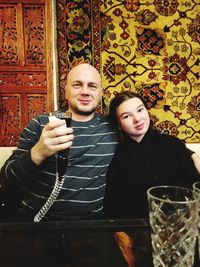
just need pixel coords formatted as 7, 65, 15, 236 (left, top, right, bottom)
0, 0, 53, 146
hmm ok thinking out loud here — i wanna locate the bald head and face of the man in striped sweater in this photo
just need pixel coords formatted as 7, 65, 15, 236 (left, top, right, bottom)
66, 63, 102, 119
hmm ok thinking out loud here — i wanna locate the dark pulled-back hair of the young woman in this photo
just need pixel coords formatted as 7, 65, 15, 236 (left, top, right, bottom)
108, 91, 152, 140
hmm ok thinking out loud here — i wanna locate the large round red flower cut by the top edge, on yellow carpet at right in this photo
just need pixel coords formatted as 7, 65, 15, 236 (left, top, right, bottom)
154, 0, 179, 16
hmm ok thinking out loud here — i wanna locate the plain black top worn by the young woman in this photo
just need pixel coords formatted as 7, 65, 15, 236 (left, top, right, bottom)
104, 130, 200, 218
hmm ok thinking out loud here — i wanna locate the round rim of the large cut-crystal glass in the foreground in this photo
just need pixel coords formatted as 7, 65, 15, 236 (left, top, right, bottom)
147, 185, 199, 204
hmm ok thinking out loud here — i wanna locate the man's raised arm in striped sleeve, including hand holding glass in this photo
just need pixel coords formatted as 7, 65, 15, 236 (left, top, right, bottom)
0, 116, 73, 197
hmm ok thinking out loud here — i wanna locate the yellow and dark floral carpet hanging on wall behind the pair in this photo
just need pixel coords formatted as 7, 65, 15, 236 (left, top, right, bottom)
58, 0, 200, 143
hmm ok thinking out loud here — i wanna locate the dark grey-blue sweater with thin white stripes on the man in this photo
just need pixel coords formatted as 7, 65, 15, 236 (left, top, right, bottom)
1, 113, 117, 219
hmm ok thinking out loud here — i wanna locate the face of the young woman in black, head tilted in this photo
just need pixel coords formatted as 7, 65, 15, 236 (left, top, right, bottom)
117, 97, 150, 142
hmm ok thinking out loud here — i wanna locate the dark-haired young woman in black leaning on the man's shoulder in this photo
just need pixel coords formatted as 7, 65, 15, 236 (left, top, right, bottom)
104, 92, 200, 218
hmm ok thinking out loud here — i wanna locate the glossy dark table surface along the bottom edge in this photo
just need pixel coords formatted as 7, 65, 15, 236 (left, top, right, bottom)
0, 219, 200, 267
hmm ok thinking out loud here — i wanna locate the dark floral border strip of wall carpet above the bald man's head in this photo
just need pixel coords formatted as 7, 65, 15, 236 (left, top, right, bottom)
56, 0, 101, 112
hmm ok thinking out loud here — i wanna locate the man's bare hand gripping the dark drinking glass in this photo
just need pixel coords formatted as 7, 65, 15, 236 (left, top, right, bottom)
31, 119, 74, 165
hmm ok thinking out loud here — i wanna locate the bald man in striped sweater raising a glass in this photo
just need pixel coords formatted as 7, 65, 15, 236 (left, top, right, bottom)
0, 63, 116, 220
